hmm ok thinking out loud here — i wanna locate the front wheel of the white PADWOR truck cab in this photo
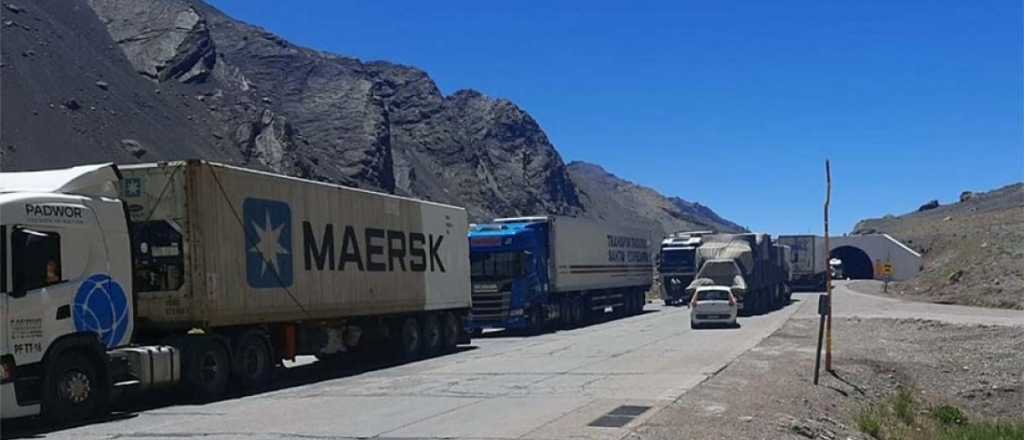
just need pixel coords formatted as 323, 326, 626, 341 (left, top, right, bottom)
43, 352, 108, 425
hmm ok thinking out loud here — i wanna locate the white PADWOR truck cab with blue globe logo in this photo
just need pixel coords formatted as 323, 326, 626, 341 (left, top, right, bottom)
0, 164, 133, 420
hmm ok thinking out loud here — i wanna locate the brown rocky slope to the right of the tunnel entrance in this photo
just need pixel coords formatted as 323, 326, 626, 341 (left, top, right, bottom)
853, 183, 1024, 309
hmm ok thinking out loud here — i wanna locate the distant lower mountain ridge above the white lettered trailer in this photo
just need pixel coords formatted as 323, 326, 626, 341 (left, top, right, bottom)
568, 162, 746, 233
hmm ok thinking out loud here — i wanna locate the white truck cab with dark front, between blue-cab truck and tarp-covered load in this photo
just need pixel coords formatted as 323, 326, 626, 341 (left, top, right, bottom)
657, 230, 715, 306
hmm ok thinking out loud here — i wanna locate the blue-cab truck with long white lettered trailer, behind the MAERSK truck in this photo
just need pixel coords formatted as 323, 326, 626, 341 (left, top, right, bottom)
469, 216, 653, 334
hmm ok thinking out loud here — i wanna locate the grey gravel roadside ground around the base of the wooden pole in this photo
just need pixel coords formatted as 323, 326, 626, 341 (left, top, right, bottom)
633, 297, 1024, 439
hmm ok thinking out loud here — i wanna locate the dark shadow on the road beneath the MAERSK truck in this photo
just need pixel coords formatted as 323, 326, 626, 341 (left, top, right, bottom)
0, 345, 477, 440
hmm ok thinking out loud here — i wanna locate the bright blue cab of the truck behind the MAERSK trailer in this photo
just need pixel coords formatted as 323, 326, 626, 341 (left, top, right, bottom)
469, 220, 549, 333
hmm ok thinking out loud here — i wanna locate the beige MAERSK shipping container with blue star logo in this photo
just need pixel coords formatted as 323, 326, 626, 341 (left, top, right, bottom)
120, 161, 470, 328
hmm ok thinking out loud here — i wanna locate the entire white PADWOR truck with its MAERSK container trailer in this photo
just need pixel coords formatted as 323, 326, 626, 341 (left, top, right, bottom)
0, 161, 470, 423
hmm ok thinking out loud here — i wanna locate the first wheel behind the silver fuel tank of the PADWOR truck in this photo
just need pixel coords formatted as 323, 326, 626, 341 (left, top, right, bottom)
182, 337, 231, 401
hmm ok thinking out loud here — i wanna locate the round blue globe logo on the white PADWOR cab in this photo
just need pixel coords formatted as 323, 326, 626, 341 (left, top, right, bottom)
72, 274, 131, 347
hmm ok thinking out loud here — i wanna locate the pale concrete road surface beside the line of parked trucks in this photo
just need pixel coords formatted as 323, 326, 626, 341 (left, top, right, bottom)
12, 304, 799, 440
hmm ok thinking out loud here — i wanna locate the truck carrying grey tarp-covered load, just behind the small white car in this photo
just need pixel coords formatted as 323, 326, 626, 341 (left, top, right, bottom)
687, 233, 791, 314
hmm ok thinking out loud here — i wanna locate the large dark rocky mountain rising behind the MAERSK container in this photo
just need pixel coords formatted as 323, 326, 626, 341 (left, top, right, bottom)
0, 0, 737, 233
